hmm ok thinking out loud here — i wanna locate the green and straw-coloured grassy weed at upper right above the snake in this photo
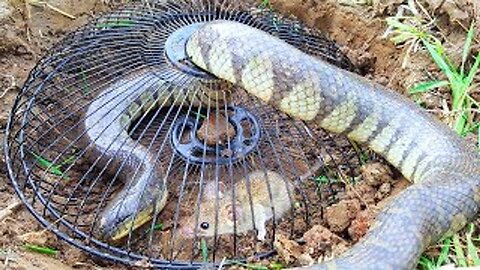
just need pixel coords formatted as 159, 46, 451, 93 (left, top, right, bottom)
387, 10, 480, 136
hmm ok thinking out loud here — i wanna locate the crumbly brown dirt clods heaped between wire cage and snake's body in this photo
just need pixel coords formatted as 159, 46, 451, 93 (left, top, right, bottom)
266, 162, 410, 265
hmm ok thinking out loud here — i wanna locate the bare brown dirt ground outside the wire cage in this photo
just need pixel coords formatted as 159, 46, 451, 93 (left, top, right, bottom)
0, 0, 480, 269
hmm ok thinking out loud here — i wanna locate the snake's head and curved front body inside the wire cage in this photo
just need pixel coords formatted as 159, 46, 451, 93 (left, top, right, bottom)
86, 69, 229, 242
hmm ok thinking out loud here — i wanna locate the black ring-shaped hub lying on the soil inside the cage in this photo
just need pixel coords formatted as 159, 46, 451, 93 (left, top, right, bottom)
171, 106, 261, 165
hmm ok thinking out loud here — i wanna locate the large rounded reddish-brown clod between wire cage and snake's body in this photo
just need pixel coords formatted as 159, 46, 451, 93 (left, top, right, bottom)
325, 199, 360, 233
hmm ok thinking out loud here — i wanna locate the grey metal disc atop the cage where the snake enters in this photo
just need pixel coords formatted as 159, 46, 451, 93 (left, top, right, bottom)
165, 23, 215, 79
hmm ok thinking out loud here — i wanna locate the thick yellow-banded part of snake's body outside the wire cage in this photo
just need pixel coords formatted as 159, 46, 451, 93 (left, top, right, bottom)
187, 21, 480, 269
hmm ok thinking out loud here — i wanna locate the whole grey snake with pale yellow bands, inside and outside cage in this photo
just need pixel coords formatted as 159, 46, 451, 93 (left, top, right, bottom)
84, 16, 480, 269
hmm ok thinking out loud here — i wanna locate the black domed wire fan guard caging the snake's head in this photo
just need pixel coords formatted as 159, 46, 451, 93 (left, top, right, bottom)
6, 0, 358, 268
